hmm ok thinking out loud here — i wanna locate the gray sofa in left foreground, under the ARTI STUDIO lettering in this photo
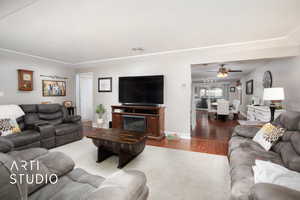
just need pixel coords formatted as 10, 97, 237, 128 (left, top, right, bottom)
0, 148, 148, 200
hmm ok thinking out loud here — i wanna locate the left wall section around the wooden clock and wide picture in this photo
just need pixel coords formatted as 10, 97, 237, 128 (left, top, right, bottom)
0, 52, 75, 104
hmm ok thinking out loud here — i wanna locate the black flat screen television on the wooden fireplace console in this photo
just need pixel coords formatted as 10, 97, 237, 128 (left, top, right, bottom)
119, 75, 164, 105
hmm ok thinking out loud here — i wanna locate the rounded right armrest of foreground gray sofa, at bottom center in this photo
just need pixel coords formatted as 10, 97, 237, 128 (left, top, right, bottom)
85, 170, 148, 200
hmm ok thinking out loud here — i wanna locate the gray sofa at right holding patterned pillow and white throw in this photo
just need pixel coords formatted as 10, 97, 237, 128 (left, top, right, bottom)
228, 112, 300, 200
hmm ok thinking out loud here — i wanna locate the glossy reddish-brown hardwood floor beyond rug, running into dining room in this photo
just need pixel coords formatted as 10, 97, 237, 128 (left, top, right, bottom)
84, 111, 238, 155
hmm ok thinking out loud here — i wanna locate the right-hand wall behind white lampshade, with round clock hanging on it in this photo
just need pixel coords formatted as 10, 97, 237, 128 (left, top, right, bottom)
241, 56, 300, 113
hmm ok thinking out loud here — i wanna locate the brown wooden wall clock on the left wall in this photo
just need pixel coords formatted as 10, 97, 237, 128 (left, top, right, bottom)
18, 69, 33, 91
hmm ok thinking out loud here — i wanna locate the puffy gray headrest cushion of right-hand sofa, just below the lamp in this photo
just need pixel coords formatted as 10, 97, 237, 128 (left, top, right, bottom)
273, 111, 300, 131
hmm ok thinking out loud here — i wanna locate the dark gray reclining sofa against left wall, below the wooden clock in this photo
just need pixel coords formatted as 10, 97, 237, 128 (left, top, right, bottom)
0, 104, 83, 152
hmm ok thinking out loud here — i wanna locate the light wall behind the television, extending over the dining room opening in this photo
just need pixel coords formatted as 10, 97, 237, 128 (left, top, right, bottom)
77, 43, 299, 135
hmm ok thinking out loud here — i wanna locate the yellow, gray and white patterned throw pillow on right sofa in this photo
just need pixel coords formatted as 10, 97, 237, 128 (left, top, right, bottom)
253, 123, 285, 151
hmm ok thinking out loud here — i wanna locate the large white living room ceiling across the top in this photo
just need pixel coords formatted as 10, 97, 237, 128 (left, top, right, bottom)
0, 0, 300, 63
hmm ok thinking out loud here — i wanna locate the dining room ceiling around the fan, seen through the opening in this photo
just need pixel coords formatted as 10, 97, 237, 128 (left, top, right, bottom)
192, 59, 271, 82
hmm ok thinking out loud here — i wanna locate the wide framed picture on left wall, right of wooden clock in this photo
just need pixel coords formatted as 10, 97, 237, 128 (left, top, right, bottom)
43, 80, 66, 97
